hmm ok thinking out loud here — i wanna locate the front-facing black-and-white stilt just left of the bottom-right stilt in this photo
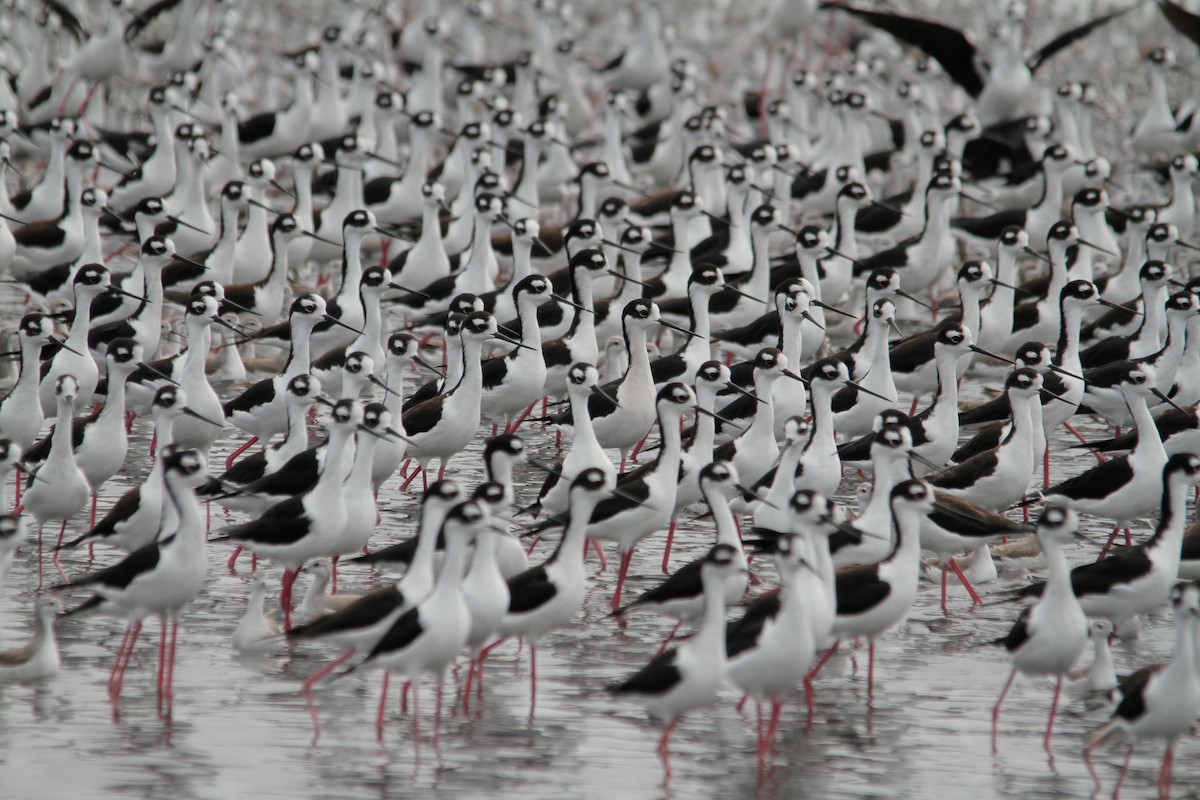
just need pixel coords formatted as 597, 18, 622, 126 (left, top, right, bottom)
991, 505, 1088, 751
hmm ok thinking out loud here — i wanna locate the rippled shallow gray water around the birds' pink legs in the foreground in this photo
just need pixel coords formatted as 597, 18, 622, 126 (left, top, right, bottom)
0, 364, 1200, 798
